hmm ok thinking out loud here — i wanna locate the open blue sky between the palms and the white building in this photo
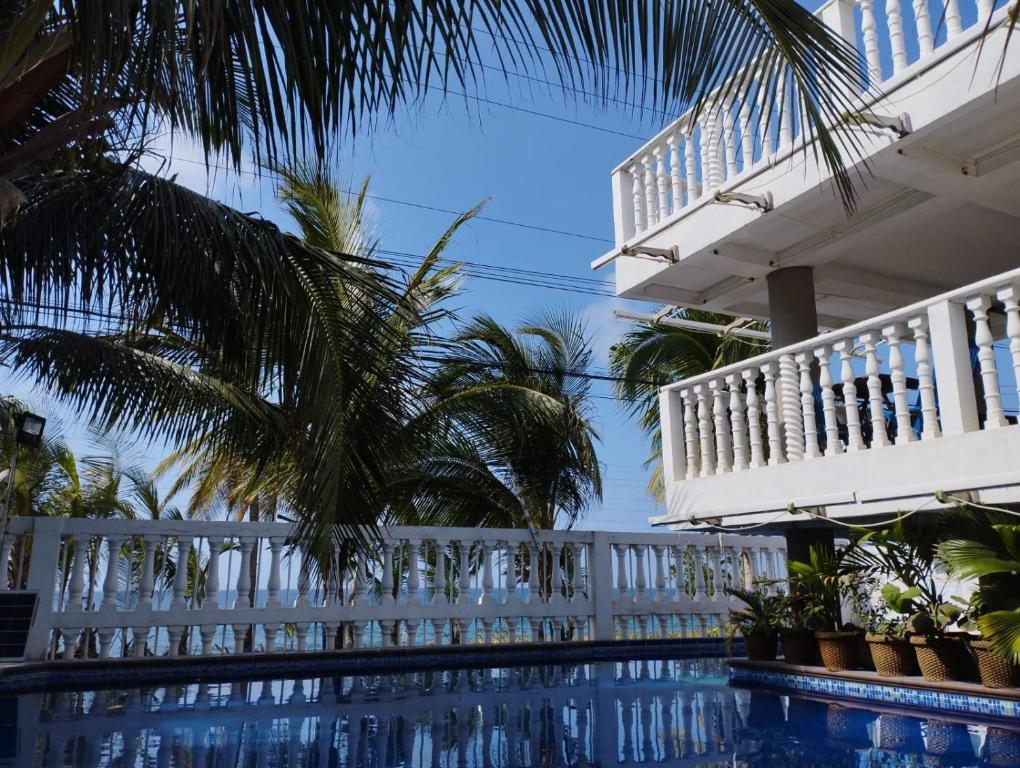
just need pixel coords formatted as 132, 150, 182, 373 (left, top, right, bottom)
14, 40, 693, 530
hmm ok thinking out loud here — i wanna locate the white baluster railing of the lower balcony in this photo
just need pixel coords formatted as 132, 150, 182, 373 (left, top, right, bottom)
660, 269, 1020, 496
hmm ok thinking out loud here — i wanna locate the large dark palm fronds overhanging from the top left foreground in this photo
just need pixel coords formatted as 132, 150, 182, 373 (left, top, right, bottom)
0, 0, 860, 535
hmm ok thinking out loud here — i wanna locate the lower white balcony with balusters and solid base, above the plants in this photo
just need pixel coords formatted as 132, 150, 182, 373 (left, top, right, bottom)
656, 269, 1020, 529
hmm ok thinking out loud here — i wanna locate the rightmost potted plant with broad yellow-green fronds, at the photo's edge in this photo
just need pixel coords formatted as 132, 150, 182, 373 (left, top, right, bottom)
938, 511, 1020, 688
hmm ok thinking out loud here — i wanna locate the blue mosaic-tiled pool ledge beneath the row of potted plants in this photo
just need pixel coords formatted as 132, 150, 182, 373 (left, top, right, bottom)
726, 659, 1020, 719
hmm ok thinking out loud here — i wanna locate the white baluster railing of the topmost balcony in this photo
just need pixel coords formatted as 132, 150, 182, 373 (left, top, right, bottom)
613, 0, 1006, 245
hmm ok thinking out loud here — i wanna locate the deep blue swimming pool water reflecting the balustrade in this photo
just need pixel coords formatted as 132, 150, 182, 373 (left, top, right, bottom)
0, 659, 1020, 768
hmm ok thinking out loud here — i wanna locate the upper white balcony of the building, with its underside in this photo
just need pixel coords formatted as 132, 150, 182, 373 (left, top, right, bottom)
594, 0, 1020, 328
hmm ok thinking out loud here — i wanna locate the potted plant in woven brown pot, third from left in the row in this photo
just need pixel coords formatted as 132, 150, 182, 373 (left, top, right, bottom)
787, 546, 860, 672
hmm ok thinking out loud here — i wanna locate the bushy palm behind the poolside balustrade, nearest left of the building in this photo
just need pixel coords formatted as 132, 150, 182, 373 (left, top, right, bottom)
393, 313, 602, 528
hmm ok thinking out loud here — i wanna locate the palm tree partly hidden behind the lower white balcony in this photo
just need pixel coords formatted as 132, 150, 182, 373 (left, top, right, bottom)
609, 309, 768, 504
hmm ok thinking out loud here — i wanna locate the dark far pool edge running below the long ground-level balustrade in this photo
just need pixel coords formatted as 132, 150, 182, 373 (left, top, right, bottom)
0, 637, 731, 693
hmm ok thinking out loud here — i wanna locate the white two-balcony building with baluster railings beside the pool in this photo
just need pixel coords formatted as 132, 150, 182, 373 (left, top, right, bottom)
593, 0, 1020, 557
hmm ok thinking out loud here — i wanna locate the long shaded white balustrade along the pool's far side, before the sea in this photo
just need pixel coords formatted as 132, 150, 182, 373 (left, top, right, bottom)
0, 517, 785, 659
